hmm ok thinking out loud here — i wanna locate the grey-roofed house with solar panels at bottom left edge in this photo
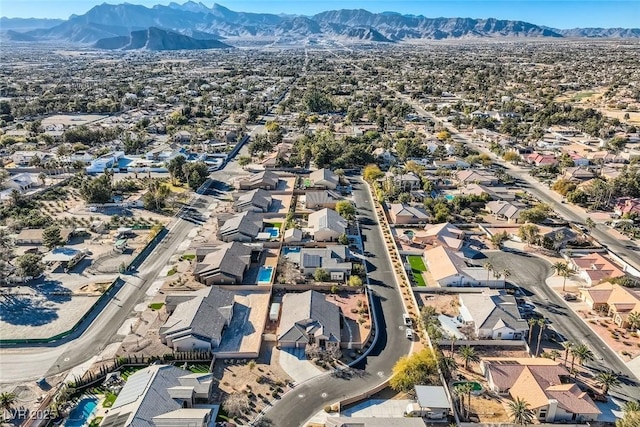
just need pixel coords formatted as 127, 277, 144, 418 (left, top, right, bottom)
102, 365, 219, 427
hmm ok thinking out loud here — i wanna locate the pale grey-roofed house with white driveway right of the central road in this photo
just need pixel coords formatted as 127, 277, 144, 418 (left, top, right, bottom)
458, 289, 529, 340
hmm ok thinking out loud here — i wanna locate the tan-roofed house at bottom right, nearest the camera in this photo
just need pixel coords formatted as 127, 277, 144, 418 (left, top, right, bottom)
480, 358, 601, 423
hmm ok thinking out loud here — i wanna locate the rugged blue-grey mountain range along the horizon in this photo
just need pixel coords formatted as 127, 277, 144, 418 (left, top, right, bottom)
0, 1, 640, 49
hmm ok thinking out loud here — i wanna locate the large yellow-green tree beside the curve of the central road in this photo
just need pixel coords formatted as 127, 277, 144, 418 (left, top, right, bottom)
389, 349, 439, 392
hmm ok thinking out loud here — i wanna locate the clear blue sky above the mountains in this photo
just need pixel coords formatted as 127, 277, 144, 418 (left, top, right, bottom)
0, 0, 640, 28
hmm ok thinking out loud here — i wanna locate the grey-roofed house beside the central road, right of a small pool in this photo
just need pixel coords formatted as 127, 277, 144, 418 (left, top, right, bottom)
290, 245, 352, 281
